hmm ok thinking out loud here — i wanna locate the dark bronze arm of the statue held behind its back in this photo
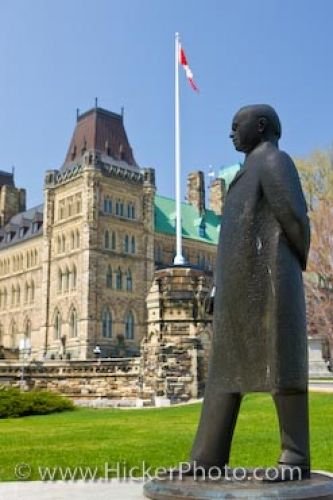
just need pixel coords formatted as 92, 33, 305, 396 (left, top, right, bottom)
260, 150, 310, 270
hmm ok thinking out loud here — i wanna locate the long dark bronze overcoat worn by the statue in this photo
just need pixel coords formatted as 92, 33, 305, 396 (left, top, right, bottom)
207, 143, 310, 392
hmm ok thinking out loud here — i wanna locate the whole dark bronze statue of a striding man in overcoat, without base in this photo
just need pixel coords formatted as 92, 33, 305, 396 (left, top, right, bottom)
191, 105, 310, 478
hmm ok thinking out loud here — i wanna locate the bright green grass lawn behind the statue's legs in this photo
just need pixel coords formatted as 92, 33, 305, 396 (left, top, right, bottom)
0, 394, 333, 481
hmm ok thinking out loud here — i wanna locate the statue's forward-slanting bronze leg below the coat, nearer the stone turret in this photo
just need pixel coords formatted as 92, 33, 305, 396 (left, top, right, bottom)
191, 387, 242, 468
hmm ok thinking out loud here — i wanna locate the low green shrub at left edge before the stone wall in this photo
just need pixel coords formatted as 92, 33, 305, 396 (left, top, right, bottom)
0, 387, 75, 418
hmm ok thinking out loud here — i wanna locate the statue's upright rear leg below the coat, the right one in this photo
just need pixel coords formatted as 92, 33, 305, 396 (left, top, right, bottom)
273, 392, 310, 471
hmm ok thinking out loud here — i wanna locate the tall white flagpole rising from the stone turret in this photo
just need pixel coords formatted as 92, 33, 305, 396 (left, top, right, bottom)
173, 33, 185, 265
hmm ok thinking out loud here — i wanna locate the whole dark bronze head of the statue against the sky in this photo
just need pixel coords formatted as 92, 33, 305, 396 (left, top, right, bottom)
230, 104, 281, 154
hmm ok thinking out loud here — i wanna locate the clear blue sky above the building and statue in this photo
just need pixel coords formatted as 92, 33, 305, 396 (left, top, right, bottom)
0, 0, 333, 206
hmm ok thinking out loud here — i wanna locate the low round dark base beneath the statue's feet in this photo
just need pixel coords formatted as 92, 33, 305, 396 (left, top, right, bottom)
144, 472, 333, 500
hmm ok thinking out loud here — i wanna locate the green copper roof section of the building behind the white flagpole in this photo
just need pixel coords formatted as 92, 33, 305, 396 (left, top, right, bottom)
155, 195, 221, 245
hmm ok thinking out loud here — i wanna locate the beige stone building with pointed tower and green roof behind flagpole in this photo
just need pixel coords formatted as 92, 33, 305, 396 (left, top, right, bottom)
0, 107, 225, 360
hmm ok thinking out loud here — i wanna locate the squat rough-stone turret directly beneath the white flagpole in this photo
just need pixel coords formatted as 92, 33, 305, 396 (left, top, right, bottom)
141, 266, 212, 405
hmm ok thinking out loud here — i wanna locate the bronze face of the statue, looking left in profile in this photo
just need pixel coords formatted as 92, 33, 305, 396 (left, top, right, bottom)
230, 110, 262, 153
